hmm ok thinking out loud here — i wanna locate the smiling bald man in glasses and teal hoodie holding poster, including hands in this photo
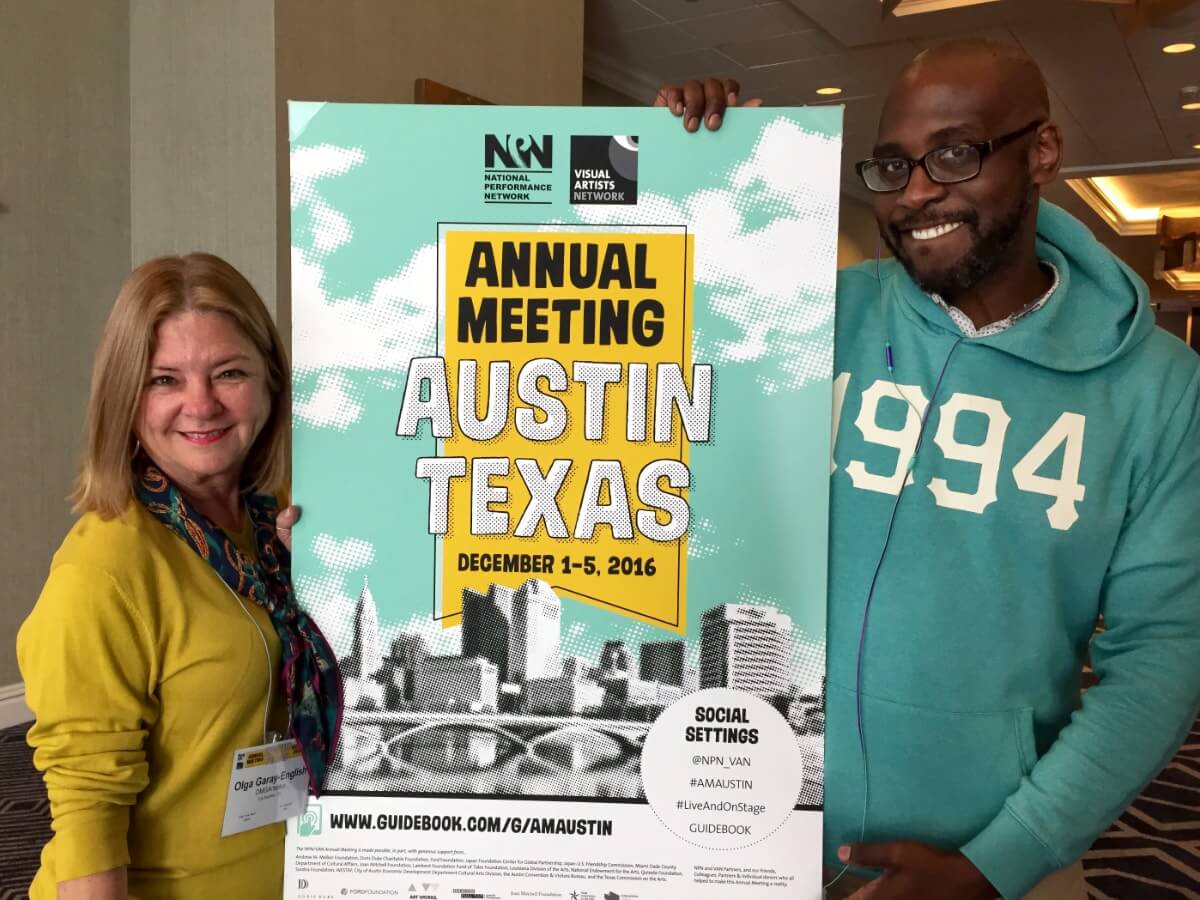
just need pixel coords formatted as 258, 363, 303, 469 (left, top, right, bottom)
656, 41, 1200, 900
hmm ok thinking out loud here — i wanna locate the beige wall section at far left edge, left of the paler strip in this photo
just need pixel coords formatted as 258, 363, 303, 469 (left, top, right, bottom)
0, 0, 130, 688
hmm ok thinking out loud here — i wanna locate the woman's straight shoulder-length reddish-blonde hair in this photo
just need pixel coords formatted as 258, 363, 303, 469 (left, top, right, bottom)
71, 253, 292, 518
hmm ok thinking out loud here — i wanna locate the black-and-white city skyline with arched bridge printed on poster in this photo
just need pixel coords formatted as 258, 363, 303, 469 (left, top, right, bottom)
331, 576, 824, 805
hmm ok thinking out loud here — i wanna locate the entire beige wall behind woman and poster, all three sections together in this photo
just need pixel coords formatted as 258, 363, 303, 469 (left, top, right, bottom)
0, 0, 583, 689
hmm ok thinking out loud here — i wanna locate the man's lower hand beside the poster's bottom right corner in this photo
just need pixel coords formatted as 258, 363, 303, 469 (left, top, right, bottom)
838, 841, 997, 900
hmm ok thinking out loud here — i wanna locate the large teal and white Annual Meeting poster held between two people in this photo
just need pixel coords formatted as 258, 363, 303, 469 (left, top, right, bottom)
286, 103, 841, 900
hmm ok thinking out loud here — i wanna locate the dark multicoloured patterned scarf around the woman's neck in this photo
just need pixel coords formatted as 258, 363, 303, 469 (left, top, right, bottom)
134, 458, 342, 797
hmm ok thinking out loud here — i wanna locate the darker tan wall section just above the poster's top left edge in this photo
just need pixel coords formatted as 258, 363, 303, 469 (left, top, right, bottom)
275, 0, 583, 340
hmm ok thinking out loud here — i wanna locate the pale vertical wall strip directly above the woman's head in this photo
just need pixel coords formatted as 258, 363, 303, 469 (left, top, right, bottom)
128, 0, 276, 311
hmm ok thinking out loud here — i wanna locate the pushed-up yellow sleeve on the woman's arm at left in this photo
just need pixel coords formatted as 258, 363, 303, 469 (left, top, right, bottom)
17, 564, 158, 881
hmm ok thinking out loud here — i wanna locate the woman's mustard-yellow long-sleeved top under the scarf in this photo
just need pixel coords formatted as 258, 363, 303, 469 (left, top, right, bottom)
17, 504, 286, 900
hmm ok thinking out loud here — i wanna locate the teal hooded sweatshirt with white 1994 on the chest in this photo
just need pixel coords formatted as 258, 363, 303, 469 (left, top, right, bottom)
826, 203, 1200, 899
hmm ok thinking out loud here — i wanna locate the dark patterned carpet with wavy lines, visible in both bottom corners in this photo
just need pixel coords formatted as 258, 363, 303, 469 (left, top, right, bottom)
0, 721, 1200, 900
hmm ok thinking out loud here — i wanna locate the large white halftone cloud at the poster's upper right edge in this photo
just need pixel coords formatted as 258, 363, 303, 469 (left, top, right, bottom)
549, 118, 841, 394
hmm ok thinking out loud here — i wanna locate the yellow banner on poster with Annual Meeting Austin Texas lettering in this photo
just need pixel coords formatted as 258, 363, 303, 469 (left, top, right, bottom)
397, 230, 712, 632
